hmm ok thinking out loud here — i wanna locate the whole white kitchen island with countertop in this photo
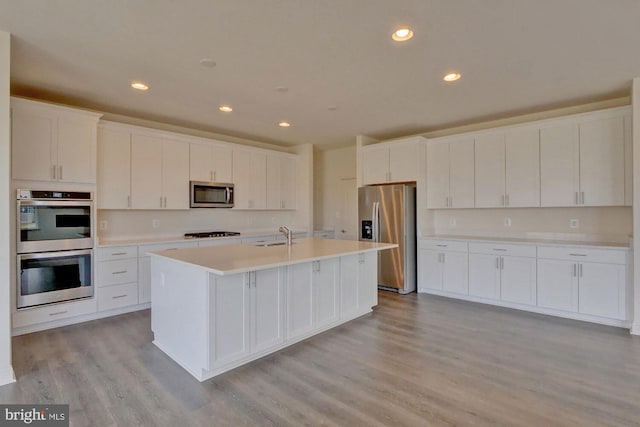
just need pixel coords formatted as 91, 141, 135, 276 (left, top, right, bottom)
150, 238, 397, 381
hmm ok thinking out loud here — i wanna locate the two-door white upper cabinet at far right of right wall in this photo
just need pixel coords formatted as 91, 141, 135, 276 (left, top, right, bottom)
540, 114, 630, 206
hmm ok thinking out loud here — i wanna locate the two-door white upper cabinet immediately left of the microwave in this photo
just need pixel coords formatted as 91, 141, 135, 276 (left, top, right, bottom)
131, 134, 189, 209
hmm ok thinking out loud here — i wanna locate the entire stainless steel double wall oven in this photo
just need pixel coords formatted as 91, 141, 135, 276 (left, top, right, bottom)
16, 190, 94, 309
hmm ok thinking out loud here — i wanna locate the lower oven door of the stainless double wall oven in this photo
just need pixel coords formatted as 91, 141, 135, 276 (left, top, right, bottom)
17, 249, 93, 308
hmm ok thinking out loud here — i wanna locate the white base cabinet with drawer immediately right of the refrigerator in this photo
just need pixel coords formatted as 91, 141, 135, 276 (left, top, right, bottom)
418, 240, 469, 295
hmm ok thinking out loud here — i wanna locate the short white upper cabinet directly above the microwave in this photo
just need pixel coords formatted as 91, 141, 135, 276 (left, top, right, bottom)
189, 143, 233, 183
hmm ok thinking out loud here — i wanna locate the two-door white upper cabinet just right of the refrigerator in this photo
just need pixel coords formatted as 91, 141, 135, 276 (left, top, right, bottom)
427, 139, 474, 209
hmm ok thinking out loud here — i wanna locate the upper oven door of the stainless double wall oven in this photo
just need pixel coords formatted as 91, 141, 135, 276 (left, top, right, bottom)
16, 200, 93, 253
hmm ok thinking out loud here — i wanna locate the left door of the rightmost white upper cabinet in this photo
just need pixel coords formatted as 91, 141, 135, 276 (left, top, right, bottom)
540, 123, 580, 206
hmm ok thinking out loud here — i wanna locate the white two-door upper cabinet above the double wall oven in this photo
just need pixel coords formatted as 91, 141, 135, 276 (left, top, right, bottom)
11, 98, 101, 184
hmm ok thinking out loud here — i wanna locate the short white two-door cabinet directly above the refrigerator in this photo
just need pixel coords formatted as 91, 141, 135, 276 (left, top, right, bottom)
362, 137, 424, 185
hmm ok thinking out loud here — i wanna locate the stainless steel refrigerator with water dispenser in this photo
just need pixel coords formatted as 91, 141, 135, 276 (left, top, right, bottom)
358, 184, 416, 294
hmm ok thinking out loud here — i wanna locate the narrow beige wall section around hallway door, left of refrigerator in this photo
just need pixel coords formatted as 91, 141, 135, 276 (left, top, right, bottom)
313, 145, 357, 230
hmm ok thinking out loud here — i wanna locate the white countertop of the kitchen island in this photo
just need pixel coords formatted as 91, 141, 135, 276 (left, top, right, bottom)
149, 238, 398, 275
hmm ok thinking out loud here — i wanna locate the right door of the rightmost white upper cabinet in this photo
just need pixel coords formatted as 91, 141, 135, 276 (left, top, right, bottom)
580, 117, 624, 206
